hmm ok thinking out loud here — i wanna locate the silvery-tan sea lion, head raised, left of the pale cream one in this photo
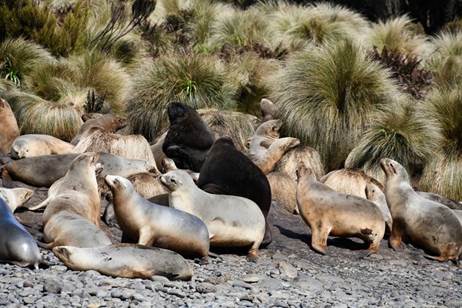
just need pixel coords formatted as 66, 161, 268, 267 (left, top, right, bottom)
106, 175, 209, 257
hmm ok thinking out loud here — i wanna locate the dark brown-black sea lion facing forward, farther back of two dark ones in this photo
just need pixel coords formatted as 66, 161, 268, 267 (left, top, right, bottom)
162, 102, 213, 172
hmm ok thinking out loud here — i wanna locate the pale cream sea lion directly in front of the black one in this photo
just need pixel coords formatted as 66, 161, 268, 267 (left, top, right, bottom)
161, 170, 265, 259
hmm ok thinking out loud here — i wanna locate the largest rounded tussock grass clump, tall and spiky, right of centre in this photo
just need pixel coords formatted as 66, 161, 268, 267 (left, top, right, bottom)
272, 41, 400, 170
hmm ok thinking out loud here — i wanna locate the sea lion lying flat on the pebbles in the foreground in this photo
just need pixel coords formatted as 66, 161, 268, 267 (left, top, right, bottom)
53, 244, 193, 280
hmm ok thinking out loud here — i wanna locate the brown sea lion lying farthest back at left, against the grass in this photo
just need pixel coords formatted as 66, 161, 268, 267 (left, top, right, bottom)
71, 114, 127, 145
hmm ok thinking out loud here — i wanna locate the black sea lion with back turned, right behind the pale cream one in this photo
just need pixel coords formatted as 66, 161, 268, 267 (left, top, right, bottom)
197, 137, 271, 245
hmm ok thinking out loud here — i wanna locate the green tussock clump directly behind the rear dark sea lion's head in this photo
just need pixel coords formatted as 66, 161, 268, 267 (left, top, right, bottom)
127, 53, 232, 140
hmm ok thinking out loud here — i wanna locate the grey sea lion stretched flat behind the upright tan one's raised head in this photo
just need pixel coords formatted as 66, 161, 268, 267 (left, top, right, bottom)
5, 152, 157, 187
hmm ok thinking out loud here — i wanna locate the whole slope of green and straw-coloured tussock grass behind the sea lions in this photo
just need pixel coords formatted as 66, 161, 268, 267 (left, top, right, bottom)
0, 0, 462, 199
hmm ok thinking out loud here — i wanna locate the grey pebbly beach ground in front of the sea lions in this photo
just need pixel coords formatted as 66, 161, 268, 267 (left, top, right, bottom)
0, 191, 462, 307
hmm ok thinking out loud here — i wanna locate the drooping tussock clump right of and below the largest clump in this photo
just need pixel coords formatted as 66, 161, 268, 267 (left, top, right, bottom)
345, 99, 441, 183
